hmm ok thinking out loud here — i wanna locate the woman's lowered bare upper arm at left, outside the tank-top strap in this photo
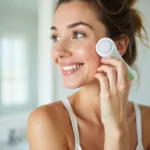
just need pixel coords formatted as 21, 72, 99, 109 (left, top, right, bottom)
28, 106, 67, 150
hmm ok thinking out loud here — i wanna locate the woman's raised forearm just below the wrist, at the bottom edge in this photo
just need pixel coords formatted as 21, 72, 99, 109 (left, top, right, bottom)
104, 125, 129, 150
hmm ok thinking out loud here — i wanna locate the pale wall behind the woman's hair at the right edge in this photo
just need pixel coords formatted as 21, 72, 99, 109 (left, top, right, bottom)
129, 0, 150, 106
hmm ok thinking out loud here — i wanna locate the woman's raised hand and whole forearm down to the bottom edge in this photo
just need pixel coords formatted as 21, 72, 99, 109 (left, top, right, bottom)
95, 58, 131, 150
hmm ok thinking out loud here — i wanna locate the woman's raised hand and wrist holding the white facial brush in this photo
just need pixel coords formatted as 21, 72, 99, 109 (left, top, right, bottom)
95, 57, 131, 134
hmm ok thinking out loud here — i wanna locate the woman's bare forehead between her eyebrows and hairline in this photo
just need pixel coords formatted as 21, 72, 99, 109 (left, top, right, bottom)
53, 1, 98, 26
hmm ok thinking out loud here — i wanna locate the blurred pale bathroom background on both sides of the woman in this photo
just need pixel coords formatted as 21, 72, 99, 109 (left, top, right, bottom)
0, 0, 150, 150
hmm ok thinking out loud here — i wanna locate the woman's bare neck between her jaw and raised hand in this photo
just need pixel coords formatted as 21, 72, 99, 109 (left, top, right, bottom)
74, 82, 101, 125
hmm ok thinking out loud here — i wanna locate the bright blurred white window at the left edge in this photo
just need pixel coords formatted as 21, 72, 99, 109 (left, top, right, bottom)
0, 38, 28, 106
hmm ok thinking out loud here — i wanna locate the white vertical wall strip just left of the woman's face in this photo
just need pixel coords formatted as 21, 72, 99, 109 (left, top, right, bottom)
38, 0, 55, 105
